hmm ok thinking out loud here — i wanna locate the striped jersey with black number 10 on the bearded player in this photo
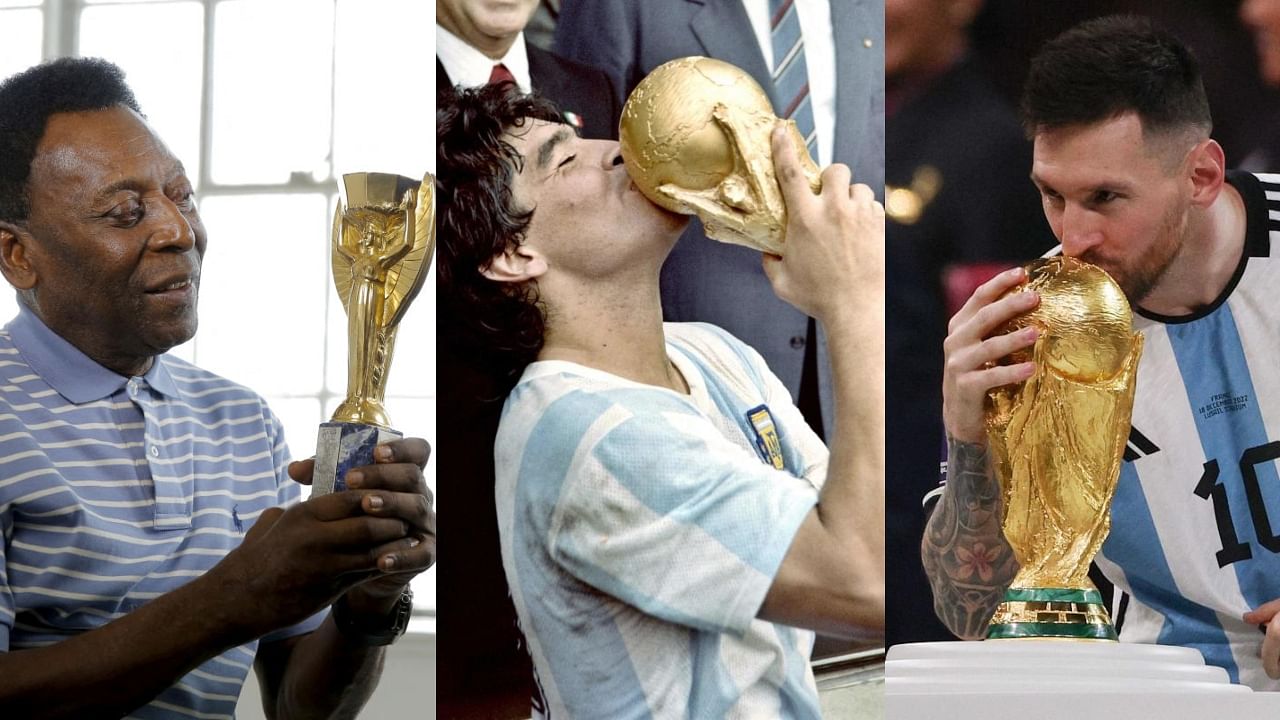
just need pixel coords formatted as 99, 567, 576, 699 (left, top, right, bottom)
1097, 173, 1280, 691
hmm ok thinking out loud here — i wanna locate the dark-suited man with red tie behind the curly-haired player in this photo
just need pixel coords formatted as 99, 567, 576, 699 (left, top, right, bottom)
435, 0, 621, 140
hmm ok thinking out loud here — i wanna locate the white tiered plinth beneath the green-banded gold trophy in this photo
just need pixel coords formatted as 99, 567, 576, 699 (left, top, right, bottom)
884, 641, 1280, 720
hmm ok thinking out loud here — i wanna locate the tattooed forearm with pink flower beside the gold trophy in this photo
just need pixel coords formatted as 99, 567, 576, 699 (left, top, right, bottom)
920, 438, 1018, 639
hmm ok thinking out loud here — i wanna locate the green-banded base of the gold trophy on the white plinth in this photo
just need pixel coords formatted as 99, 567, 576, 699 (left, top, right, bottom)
987, 588, 1117, 641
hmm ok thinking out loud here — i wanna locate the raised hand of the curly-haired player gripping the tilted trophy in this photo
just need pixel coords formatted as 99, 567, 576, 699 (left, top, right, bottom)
764, 123, 884, 322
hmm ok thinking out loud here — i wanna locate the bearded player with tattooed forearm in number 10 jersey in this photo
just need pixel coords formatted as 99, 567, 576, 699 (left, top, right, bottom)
923, 18, 1280, 691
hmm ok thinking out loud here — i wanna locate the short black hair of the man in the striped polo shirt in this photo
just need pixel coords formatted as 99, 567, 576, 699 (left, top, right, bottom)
0, 58, 142, 223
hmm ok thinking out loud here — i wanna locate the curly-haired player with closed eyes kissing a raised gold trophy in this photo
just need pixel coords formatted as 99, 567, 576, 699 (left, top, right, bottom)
438, 86, 884, 717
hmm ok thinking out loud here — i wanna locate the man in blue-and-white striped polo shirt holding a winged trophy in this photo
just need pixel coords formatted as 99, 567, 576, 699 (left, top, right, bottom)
0, 59, 435, 717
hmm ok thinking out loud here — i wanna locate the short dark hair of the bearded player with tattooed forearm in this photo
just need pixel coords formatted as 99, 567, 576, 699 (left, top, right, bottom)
1021, 15, 1213, 137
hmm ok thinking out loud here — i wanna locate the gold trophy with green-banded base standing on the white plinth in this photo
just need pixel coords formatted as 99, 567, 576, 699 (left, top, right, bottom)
987, 258, 1142, 641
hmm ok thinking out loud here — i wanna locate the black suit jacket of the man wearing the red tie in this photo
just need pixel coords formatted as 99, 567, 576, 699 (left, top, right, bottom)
435, 45, 622, 140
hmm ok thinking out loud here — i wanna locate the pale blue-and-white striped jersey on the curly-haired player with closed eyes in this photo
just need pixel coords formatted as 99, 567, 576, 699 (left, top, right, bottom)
495, 323, 827, 720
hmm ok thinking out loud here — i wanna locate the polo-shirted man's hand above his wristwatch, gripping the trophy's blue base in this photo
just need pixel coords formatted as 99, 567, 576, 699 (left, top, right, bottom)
289, 438, 435, 614
